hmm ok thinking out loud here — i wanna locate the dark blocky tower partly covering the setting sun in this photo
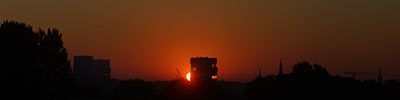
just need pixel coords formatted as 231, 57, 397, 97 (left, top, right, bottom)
190, 57, 218, 82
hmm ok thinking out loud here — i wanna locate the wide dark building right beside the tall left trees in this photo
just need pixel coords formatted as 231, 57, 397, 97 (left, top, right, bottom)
74, 56, 111, 94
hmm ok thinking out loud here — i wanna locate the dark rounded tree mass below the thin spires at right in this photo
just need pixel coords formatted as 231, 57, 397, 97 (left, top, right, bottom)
246, 61, 399, 99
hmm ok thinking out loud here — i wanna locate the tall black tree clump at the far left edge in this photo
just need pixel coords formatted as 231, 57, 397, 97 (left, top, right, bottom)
0, 20, 72, 99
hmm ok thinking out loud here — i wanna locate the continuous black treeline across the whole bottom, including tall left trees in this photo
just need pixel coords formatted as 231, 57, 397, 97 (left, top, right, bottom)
0, 21, 400, 100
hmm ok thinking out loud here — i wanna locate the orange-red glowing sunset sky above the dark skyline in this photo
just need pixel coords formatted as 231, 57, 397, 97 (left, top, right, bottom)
0, 0, 400, 82
